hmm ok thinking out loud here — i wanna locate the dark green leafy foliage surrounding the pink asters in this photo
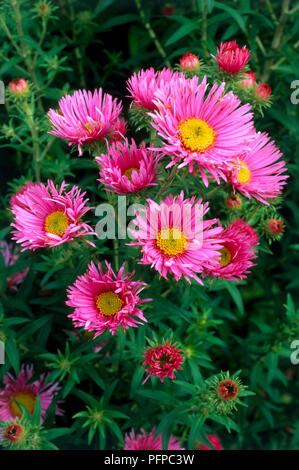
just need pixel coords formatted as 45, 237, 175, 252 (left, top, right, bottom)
0, 0, 299, 449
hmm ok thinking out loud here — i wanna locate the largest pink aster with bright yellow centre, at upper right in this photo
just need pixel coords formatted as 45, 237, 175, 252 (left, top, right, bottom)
148, 77, 254, 186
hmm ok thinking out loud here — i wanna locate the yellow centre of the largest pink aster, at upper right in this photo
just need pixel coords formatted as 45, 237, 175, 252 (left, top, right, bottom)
178, 118, 215, 152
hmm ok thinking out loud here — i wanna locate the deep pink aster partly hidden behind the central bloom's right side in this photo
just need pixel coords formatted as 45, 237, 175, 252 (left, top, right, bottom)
207, 219, 258, 281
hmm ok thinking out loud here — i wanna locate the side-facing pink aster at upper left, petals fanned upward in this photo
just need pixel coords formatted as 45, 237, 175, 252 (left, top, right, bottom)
48, 88, 122, 155
